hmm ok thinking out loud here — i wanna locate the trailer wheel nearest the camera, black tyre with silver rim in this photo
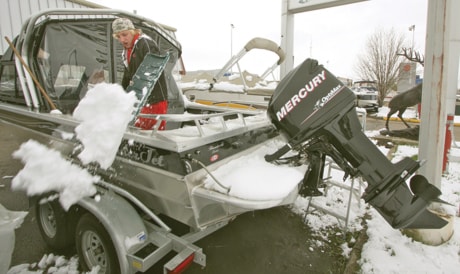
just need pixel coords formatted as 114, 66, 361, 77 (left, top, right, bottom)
76, 213, 120, 274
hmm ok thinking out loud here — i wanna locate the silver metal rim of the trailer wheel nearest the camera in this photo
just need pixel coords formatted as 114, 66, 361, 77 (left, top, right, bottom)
81, 231, 108, 273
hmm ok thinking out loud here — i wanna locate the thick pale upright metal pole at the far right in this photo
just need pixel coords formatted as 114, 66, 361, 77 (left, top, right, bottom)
419, 0, 460, 188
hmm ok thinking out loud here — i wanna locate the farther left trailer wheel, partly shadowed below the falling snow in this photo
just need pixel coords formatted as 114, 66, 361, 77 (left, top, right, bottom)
35, 200, 73, 250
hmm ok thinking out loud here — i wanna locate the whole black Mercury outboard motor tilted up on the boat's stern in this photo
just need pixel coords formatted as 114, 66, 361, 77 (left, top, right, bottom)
265, 59, 447, 228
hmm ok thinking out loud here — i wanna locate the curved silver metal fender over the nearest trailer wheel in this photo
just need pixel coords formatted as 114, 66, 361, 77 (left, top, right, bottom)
78, 191, 148, 273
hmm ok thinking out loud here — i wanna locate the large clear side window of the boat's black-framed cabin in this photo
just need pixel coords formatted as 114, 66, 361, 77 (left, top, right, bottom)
35, 21, 111, 113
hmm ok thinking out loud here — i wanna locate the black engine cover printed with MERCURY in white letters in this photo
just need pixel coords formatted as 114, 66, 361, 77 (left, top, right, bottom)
268, 59, 356, 140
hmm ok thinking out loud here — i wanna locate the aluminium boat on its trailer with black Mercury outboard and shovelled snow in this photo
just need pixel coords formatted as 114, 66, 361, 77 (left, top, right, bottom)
0, 7, 445, 273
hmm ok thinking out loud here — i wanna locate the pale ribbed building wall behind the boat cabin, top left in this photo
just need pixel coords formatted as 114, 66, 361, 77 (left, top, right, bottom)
0, 0, 103, 55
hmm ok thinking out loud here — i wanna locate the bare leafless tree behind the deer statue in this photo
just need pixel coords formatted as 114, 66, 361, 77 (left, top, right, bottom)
356, 29, 405, 106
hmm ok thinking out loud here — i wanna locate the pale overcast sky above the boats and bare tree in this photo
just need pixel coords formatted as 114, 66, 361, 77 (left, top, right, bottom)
90, 0, 427, 80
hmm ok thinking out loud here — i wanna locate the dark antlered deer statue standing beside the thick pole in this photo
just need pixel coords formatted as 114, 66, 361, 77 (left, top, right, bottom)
385, 48, 424, 131
